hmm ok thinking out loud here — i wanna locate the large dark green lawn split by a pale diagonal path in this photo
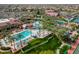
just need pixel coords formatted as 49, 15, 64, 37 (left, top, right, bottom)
23, 37, 61, 54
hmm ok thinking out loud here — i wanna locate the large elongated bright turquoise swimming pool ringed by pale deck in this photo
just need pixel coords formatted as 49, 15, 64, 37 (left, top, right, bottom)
12, 30, 32, 41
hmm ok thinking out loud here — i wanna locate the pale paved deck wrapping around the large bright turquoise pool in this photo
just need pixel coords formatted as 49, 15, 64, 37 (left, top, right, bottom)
0, 29, 51, 53
